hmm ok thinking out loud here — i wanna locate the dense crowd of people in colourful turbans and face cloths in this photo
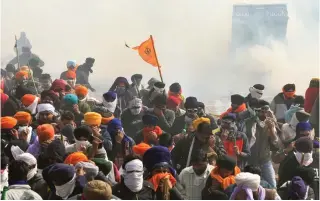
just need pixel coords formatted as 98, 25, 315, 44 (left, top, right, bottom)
0, 42, 319, 200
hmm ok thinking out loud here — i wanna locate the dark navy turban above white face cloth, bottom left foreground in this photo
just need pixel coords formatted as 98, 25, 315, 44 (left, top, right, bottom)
44, 163, 76, 186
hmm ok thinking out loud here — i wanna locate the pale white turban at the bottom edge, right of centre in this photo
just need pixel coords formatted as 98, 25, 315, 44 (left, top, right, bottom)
235, 172, 260, 191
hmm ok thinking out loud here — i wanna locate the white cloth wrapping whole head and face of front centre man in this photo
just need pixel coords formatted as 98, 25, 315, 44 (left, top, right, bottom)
123, 159, 143, 193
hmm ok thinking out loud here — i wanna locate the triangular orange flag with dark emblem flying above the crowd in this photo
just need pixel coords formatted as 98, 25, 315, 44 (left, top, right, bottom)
132, 36, 160, 68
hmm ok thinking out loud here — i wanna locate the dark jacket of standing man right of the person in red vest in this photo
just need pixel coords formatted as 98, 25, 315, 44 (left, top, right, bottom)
245, 117, 278, 166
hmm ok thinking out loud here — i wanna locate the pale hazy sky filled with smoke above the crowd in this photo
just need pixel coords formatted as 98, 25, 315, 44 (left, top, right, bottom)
1, 0, 319, 112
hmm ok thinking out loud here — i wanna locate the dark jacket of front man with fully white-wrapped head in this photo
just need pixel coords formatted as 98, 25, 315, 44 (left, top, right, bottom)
112, 179, 156, 200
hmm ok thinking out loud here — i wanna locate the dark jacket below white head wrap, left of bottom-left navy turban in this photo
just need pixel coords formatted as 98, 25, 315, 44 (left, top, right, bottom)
28, 173, 49, 200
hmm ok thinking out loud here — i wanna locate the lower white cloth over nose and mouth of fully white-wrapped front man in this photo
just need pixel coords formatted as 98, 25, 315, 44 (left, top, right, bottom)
123, 171, 143, 193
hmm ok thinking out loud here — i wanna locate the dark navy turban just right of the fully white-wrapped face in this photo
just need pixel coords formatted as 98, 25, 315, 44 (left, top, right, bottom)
143, 146, 171, 172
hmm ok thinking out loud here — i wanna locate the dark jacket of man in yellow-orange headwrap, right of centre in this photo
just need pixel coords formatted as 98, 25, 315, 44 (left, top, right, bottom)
171, 134, 226, 174
